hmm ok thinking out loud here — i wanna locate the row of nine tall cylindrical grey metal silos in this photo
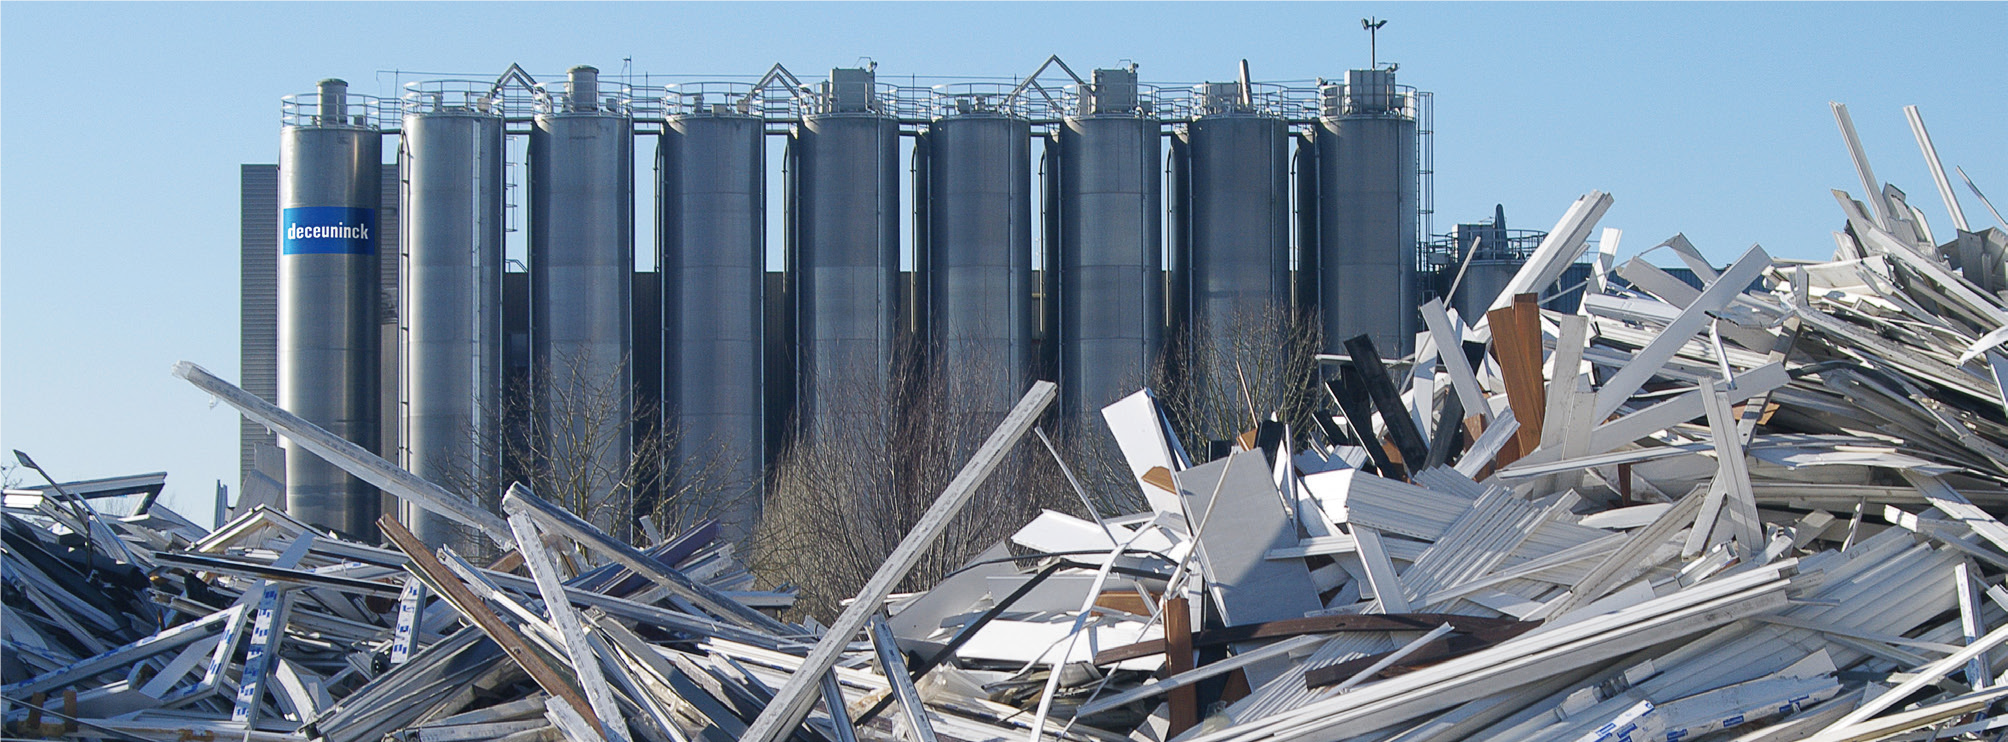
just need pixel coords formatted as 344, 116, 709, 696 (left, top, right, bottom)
281, 60, 1416, 533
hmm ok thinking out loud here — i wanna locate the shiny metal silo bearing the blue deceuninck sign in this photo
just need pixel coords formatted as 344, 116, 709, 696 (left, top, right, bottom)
279, 80, 384, 537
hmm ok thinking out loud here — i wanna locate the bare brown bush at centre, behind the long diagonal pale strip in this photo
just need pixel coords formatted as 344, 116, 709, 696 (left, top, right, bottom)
751, 346, 1080, 620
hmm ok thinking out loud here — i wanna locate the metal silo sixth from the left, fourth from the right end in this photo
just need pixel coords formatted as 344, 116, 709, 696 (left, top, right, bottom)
920, 86, 1032, 419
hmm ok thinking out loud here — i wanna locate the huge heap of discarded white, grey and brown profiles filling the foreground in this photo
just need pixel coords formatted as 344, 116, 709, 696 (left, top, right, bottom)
19, 105, 2008, 742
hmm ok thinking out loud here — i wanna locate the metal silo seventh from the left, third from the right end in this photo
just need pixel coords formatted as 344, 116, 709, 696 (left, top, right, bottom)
1048, 68, 1165, 429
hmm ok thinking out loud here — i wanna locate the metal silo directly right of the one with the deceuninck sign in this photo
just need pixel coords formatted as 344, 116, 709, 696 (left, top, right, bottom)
398, 82, 506, 551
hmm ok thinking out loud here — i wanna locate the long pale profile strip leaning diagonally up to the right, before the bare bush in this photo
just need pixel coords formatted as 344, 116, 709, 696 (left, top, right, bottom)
745, 381, 1058, 742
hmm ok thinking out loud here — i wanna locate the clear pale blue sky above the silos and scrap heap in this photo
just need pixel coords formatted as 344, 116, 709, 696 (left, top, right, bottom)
0, 0, 2008, 517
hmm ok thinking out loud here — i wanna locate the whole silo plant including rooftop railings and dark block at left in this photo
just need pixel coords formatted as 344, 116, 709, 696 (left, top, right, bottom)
243, 58, 1476, 541
